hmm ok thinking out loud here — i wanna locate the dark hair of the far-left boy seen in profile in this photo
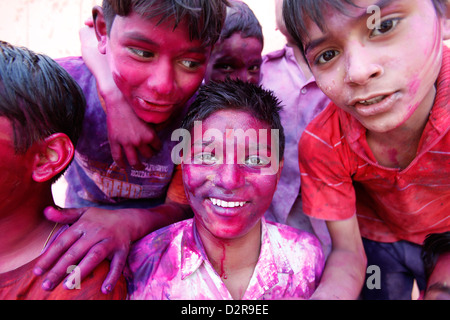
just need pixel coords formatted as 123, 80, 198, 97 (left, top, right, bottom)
0, 41, 86, 180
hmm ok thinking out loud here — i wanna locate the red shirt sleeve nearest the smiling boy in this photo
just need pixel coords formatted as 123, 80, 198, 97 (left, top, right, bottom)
299, 105, 356, 220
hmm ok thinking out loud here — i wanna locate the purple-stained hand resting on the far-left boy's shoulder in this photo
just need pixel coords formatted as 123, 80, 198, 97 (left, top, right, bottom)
34, 207, 132, 294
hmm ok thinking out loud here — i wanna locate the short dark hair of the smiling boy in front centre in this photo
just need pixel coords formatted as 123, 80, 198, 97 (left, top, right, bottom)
182, 79, 285, 159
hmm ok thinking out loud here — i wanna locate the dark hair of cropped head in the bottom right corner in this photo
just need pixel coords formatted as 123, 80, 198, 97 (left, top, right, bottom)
422, 231, 450, 278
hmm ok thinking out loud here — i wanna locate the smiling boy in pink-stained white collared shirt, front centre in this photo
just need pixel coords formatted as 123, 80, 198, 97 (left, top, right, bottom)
126, 80, 323, 300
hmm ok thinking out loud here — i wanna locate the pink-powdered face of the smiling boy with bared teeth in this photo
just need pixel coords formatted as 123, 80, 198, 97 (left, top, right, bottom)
182, 110, 280, 240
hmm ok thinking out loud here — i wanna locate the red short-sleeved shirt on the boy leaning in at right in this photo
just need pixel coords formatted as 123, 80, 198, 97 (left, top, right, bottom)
299, 48, 450, 244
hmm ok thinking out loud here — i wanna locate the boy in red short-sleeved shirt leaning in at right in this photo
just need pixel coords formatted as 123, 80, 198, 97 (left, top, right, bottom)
283, 0, 450, 299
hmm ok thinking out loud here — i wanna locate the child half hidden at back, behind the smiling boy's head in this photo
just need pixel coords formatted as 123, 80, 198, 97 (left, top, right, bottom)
205, 0, 264, 84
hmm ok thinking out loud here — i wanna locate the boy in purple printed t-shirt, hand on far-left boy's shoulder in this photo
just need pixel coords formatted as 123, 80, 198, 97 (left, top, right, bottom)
35, 0, 226, 292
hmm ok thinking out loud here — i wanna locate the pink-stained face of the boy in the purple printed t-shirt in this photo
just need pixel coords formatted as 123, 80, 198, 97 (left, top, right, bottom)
99, 13, 211, 124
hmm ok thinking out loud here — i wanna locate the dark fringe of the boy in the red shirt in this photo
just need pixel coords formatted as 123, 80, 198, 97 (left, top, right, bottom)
283, 0, 448, 57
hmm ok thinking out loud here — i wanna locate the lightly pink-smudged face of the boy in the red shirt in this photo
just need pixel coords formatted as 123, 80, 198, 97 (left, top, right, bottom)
305, 0, 443, 134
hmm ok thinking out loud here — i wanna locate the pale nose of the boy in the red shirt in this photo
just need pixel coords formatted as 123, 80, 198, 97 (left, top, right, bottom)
344, 44, 383, 85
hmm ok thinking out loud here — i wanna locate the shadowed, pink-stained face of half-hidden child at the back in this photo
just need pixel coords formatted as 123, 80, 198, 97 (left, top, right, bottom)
205, 32, 263, 84
